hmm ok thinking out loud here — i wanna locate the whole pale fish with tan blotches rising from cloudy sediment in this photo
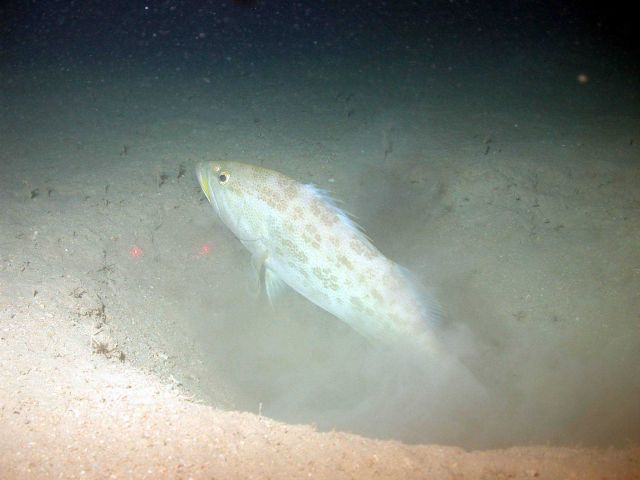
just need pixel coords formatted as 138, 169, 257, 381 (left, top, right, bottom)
196, 161, 441, 355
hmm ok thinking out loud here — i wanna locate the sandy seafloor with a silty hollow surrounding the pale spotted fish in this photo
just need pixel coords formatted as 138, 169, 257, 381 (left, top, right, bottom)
0, 47, 640, 478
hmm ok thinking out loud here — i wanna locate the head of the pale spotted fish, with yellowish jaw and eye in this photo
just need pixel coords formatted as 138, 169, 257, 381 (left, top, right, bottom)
196, 161, 265, 241
